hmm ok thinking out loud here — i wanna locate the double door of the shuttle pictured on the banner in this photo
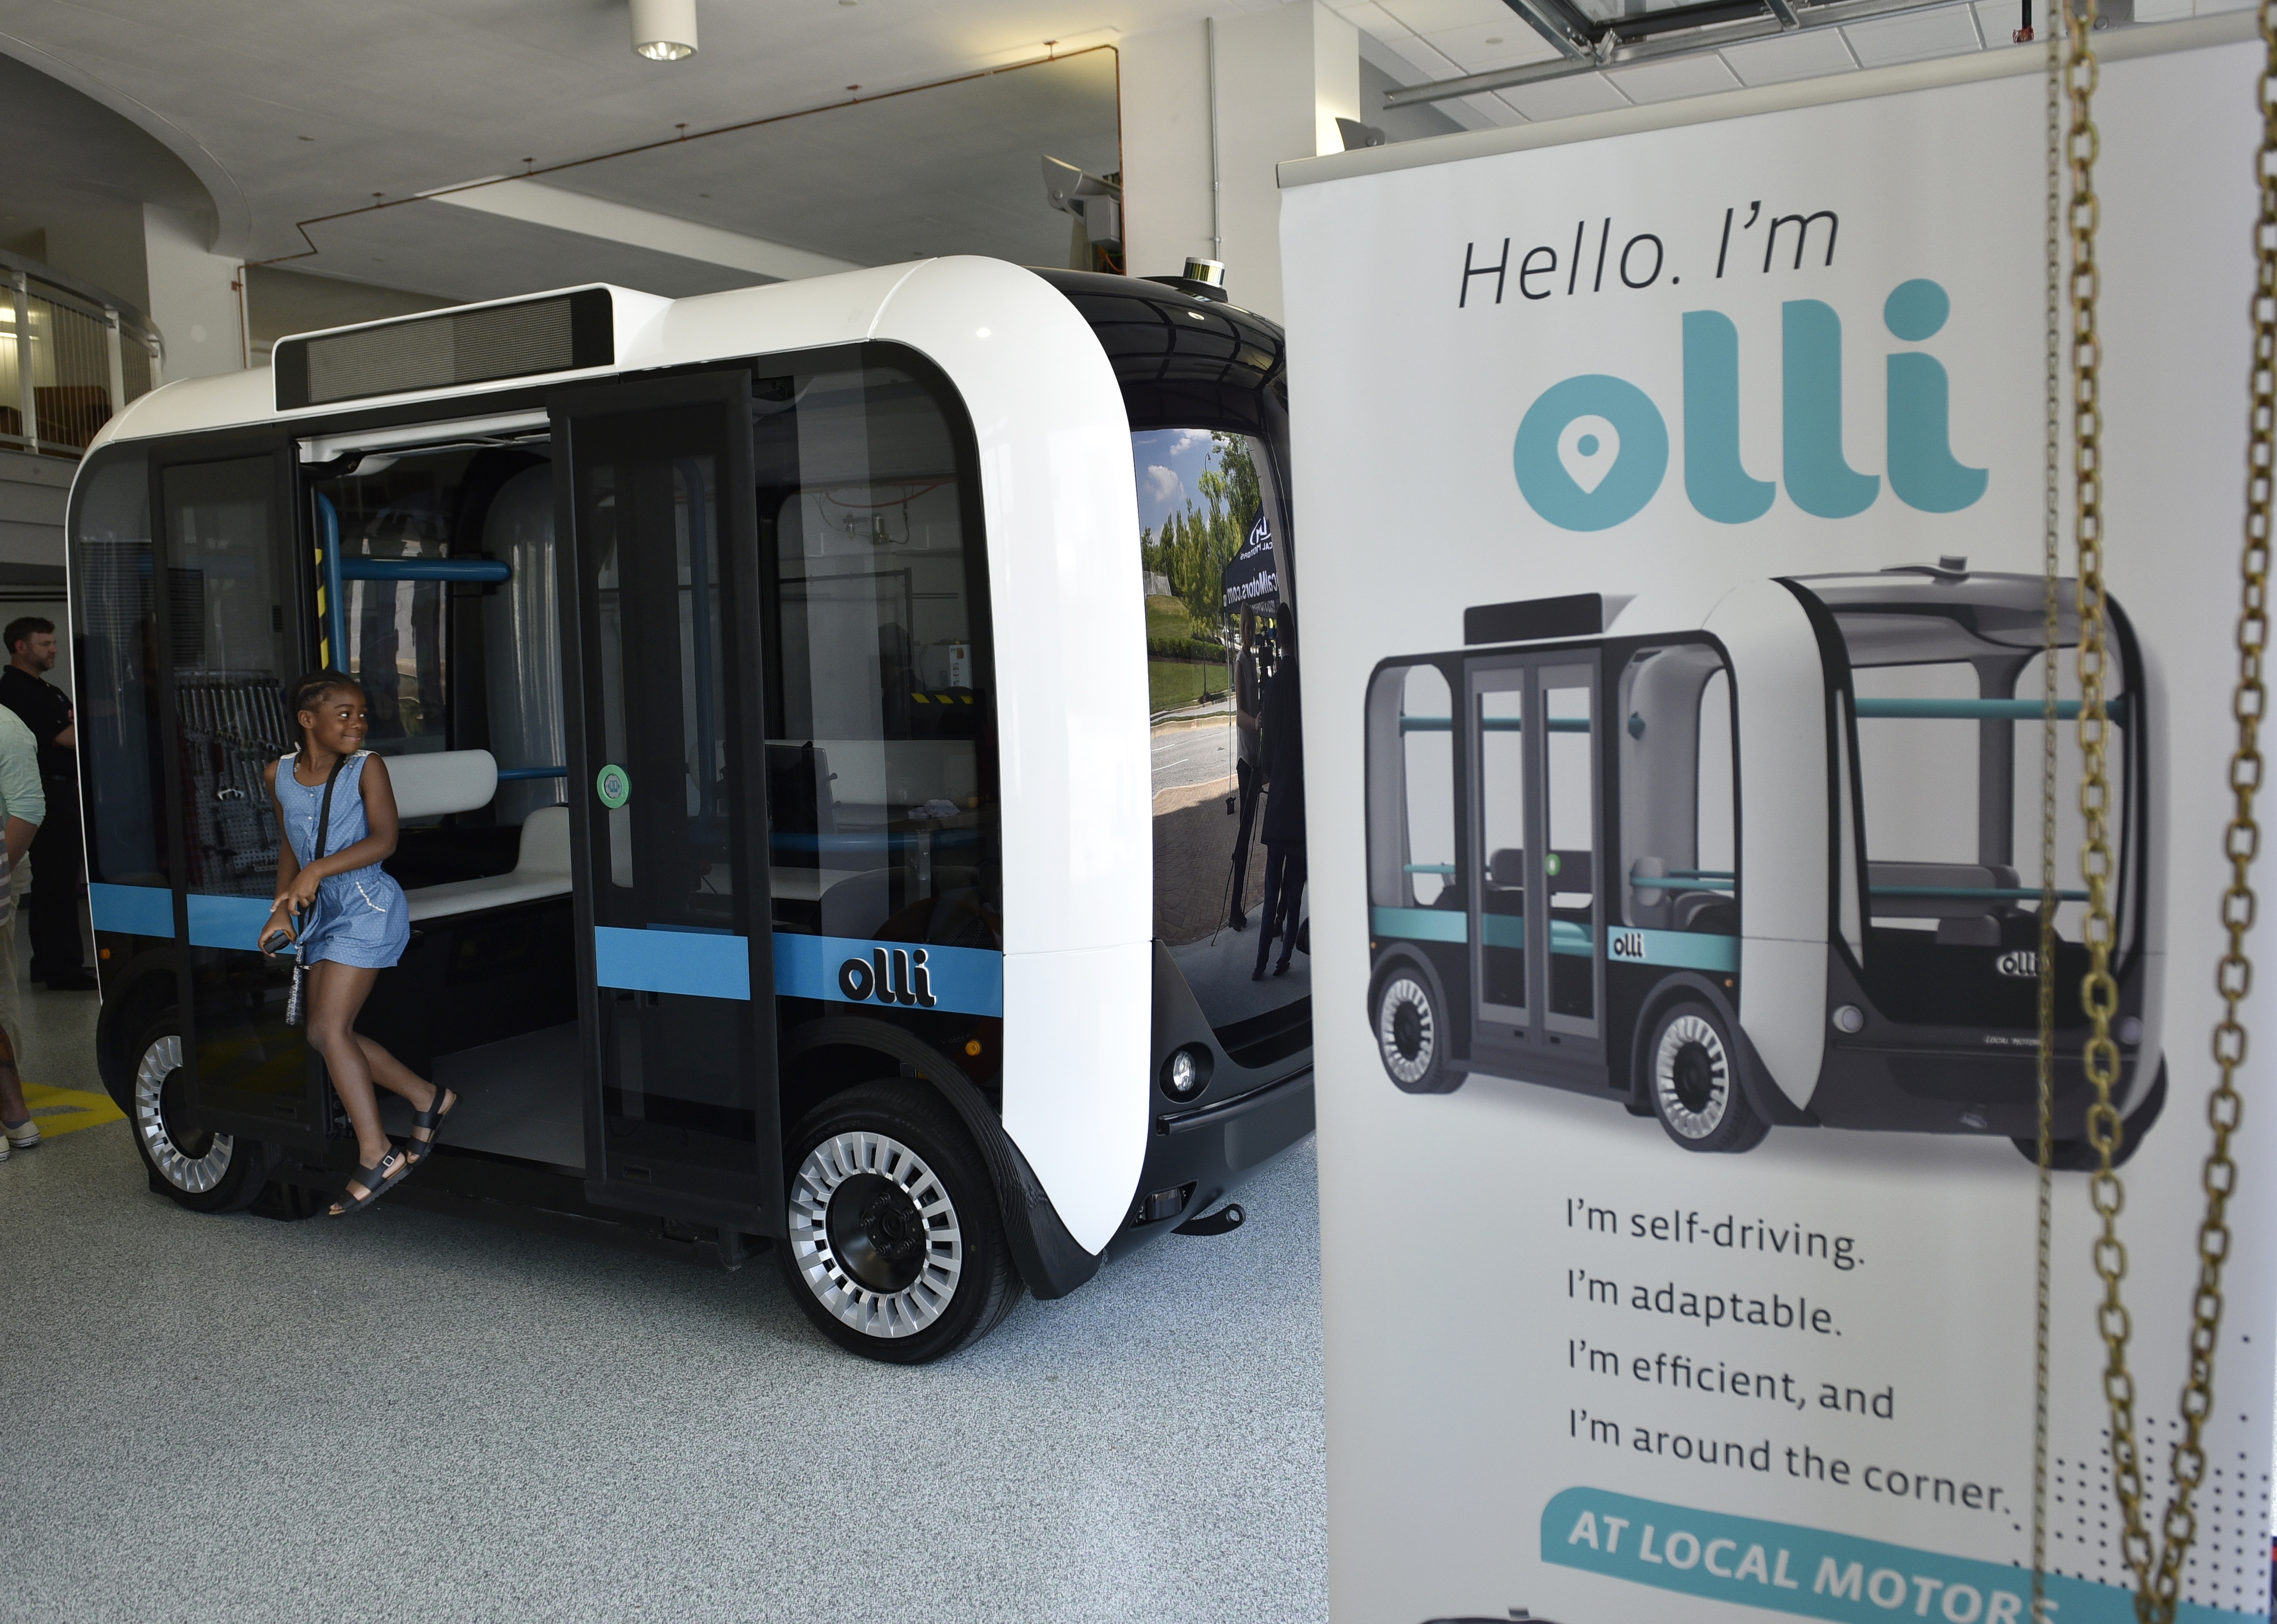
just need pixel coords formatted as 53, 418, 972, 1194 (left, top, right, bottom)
1466, 649, 1606, 1066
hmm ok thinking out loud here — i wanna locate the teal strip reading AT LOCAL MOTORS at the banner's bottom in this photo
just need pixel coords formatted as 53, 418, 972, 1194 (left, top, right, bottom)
1542, 1485, 2259, 1624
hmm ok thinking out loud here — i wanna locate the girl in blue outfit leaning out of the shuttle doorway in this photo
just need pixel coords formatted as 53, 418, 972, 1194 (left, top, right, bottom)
260, 672, 458, 1219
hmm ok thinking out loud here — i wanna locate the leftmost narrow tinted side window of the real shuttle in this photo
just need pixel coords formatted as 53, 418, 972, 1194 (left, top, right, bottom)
71, 455, 168, 886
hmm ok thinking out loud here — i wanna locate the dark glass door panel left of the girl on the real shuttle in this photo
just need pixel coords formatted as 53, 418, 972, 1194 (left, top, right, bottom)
151, 444, 330, 1150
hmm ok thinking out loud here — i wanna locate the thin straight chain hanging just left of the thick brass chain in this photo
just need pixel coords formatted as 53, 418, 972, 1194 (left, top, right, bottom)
2031, 7, 2063, 1624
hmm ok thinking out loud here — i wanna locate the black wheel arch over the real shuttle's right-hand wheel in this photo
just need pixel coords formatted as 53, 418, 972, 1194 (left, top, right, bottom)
783, 1016, 1100, 1301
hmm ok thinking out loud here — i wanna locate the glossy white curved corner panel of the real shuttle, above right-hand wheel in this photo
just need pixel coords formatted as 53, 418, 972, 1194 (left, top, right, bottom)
872, 260, 1155, 1253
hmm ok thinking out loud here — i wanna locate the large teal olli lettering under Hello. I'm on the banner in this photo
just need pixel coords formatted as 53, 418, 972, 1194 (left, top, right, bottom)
1512, 278, 1990, 531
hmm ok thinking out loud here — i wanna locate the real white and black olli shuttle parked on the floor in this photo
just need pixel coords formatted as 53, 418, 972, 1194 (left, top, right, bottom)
68, 260, 1312, 1362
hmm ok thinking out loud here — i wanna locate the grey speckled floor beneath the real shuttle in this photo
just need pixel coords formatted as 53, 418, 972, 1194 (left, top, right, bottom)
0, 1075, 1328, 1624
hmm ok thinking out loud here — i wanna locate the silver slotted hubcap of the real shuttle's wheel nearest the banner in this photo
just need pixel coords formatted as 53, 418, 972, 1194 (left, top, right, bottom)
790, 1130, 965, 1337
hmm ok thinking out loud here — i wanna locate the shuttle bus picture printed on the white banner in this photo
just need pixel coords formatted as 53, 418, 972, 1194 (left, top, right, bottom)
1366, 576, 2166, 1169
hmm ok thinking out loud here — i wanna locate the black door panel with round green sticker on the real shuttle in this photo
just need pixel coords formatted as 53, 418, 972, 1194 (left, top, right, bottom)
551, 371, 783, 1234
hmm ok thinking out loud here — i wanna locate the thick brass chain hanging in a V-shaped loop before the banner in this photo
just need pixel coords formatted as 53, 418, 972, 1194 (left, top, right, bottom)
2063, 0, 2277, 1624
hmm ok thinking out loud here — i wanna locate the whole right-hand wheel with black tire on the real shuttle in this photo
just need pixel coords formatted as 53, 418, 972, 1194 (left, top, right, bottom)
774, 1077, 1025, 1364
